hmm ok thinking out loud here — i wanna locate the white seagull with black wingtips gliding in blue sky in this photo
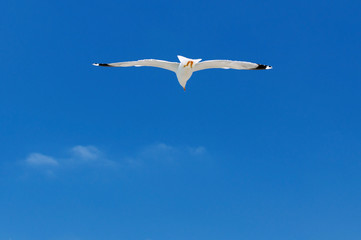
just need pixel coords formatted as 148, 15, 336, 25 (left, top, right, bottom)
93, 55, 272, 91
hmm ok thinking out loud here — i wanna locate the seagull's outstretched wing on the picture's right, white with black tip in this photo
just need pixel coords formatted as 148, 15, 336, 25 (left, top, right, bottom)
193, 60, 272, 71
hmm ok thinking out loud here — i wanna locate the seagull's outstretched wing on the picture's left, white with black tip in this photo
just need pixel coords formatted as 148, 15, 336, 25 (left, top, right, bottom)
93, 59, 179, 72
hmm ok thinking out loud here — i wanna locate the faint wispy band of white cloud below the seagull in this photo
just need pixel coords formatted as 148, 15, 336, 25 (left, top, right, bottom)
25, 143, 208, 175
